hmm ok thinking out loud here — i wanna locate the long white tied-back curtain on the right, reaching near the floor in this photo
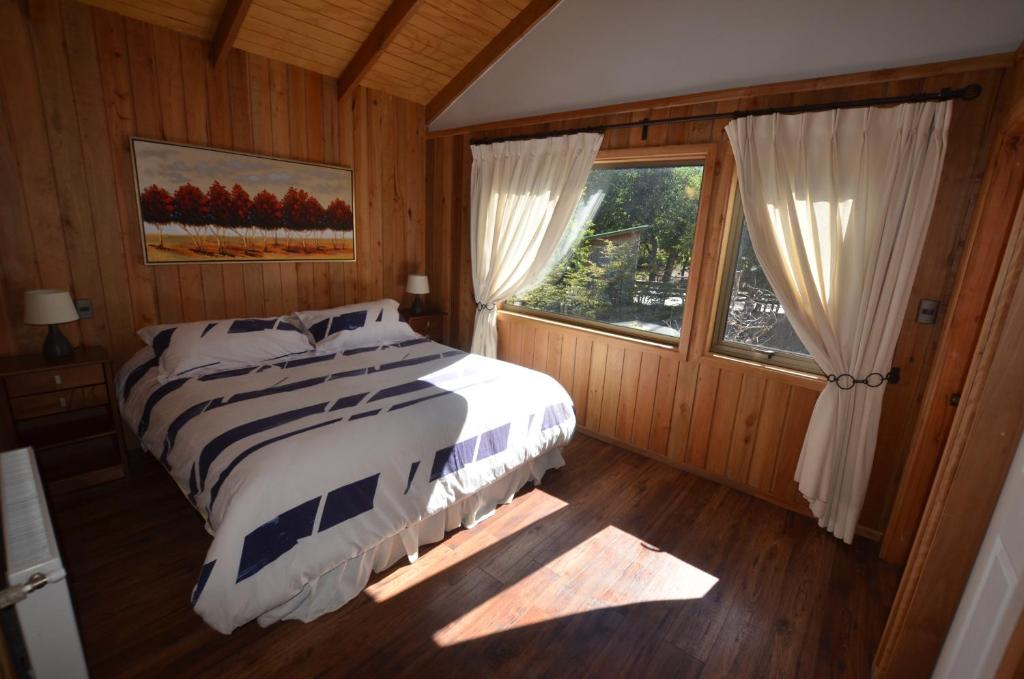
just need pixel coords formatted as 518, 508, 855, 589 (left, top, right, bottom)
726, 101, 951, 542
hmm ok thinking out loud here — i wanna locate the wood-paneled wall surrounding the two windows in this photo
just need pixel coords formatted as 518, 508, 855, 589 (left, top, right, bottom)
428, 66, 1008, 537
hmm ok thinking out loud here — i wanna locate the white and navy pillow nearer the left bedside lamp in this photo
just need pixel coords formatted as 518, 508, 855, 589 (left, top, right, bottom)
138, 316, 313, 382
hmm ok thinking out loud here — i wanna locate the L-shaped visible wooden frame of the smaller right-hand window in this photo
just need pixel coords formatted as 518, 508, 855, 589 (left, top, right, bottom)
710, 180, 824, 376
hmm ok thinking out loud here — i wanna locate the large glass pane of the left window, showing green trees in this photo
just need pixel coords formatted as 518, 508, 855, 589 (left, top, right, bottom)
509, 165, 703, 339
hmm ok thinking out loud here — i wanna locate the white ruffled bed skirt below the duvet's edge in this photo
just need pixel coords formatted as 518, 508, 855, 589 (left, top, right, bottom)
251, 447, 565, 627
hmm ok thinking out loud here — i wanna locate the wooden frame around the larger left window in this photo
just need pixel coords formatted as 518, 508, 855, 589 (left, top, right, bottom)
499, 143, 716, 351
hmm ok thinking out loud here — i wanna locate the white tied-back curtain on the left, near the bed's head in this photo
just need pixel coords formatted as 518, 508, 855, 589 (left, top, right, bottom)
470, 133, 603, 356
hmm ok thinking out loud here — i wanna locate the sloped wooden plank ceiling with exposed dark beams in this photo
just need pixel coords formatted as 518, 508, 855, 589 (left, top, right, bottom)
83, 0, 557, 119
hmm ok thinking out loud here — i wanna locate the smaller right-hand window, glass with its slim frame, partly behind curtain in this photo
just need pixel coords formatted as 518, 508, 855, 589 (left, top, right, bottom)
712, 190, 819, 372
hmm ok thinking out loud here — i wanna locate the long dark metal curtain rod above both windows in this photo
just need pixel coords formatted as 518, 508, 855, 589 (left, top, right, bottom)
470, 84, 981, 146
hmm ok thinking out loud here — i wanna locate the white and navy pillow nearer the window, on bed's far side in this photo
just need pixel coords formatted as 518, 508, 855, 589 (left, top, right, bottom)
295, 299, 419, 352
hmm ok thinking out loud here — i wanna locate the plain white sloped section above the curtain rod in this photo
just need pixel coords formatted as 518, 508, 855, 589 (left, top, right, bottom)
430, 0, 1024, 130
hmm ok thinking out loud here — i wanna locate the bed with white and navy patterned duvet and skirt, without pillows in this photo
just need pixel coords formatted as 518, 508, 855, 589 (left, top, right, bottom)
117, 338, 575, 634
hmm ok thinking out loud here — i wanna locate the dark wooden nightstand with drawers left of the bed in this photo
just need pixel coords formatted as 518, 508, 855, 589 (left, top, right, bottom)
0, 347, 125, 493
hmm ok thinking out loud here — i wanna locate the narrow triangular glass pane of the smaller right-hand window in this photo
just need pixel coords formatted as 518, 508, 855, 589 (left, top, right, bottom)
723, 209, 810, 357
